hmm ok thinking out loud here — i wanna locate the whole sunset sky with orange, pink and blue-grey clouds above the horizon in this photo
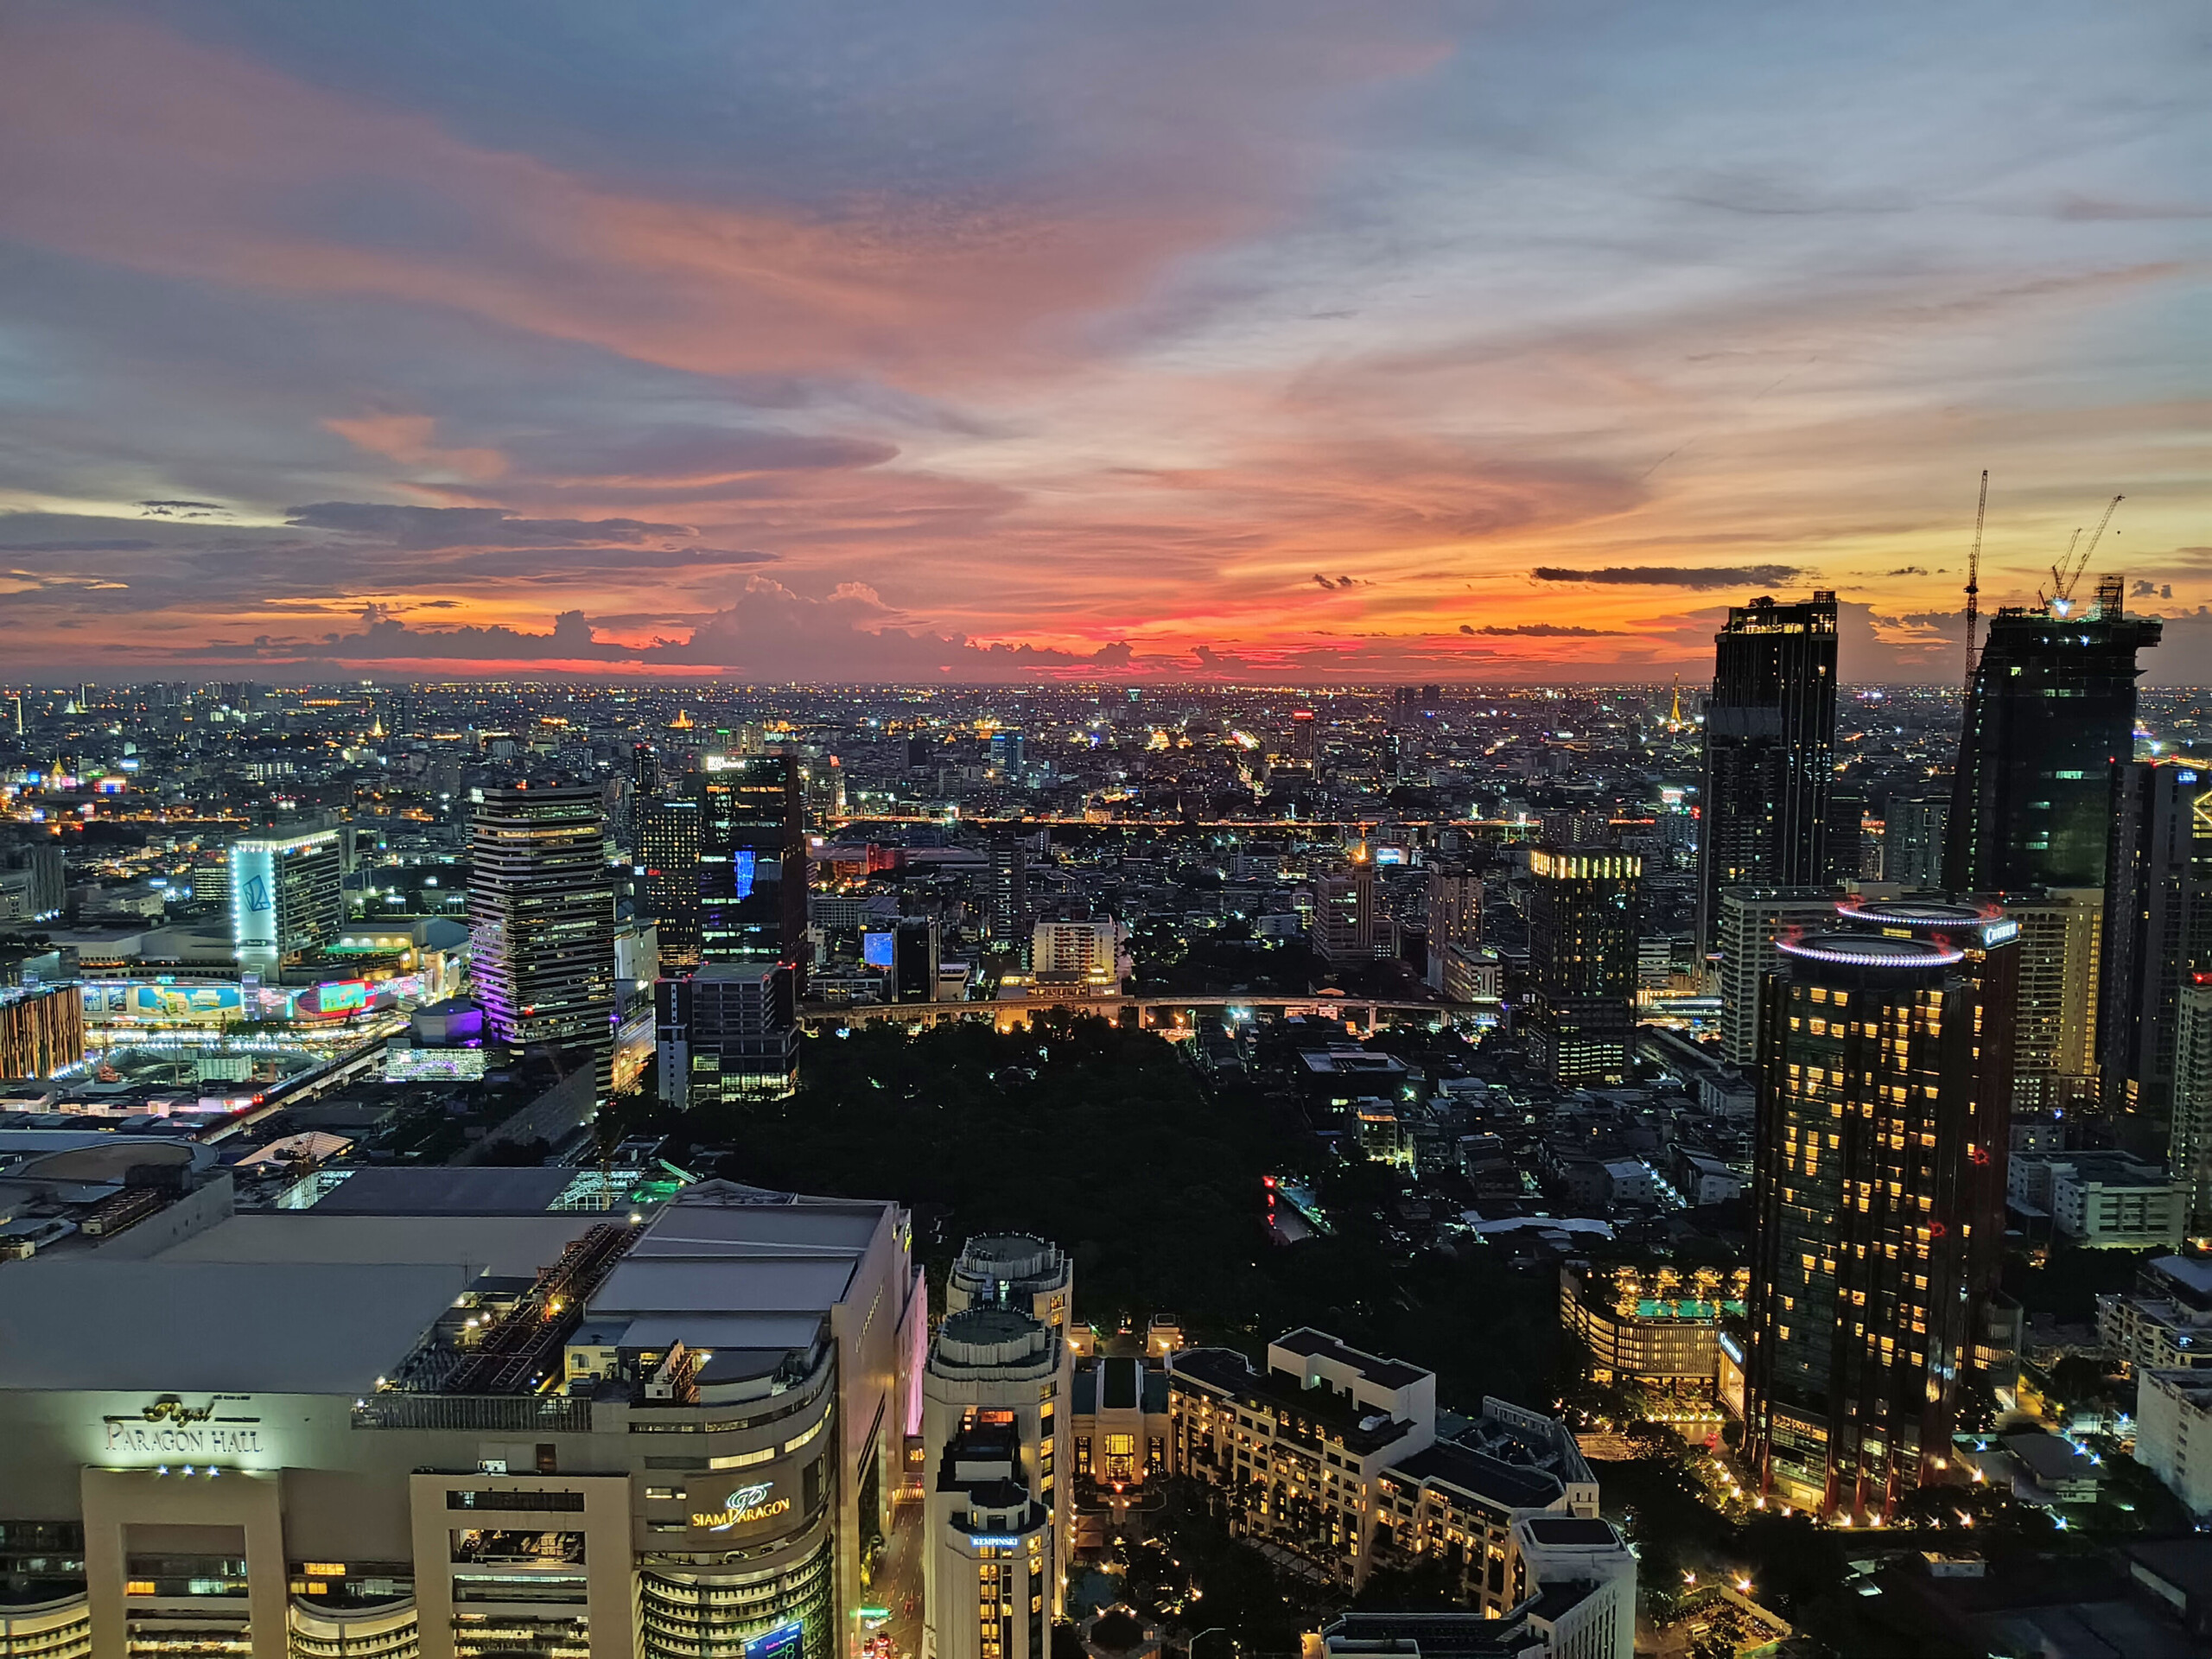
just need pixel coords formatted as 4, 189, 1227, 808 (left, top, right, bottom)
0, 0, 2212, 683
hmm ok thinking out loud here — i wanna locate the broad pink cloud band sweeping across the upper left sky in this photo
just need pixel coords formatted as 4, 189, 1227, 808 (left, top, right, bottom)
0, 9, 1422, 385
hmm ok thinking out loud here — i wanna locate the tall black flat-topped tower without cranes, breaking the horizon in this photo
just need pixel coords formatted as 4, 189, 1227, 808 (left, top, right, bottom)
1697, 588, 1836, 951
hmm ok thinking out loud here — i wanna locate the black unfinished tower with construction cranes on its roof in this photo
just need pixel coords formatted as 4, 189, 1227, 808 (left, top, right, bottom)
1944, 577, 2161, 893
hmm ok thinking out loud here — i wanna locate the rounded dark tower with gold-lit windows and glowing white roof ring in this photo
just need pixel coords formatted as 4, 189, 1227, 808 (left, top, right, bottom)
1745, 905, 2015, 1520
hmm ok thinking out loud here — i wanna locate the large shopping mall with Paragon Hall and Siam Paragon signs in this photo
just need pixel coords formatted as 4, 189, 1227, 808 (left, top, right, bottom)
0, 1170, 927, 1659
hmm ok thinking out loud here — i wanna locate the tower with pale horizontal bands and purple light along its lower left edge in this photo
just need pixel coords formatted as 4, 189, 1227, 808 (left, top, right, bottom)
469, 783, 615, 1097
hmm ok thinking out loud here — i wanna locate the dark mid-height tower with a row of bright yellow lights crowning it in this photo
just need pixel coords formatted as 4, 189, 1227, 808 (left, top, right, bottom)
1524, 847, 1643, 1084
